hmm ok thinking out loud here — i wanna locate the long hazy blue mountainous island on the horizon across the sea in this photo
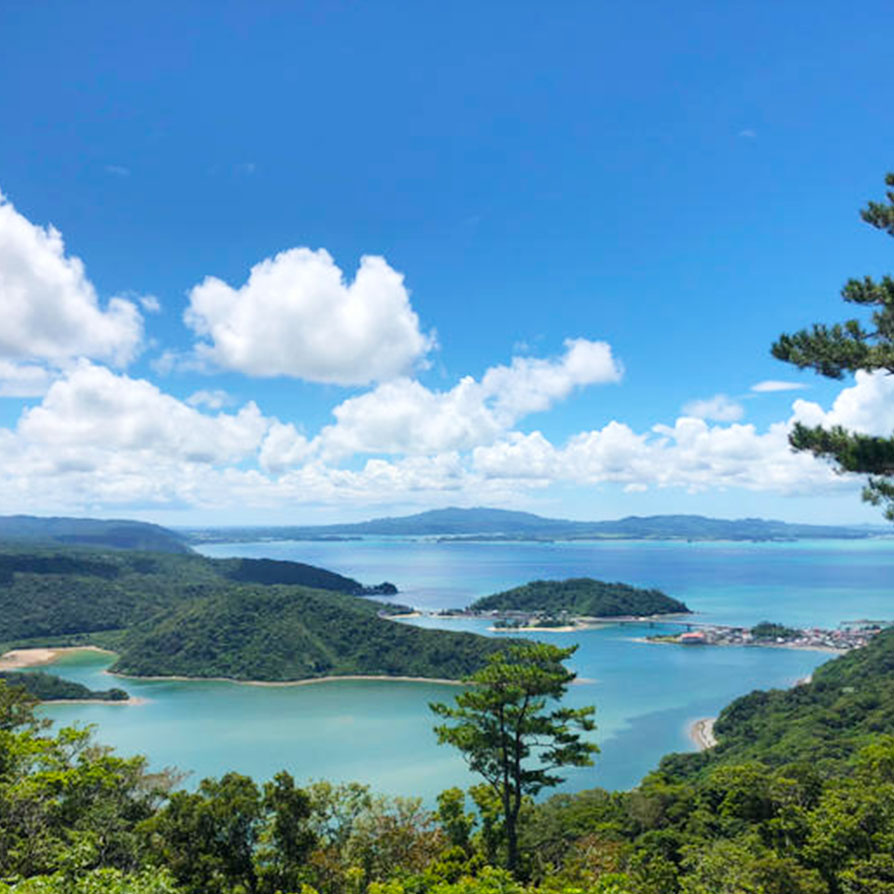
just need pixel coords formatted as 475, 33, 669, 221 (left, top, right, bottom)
182, 508, 878, 544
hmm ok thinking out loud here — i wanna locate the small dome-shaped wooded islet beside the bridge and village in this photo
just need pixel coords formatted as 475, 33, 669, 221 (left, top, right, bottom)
469, 577, 689, 618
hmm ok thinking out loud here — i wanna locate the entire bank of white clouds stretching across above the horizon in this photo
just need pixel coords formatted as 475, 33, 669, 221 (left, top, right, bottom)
0, 187, 880, 513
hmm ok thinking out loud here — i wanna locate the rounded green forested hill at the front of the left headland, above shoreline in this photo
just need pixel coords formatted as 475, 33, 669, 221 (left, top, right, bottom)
113, 586, 508, 680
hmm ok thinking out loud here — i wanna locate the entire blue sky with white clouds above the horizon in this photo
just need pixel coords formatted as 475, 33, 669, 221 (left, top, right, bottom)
0, 0, 894, 524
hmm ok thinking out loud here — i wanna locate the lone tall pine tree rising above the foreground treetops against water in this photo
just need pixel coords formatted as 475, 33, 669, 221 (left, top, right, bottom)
430, 643, 599, 872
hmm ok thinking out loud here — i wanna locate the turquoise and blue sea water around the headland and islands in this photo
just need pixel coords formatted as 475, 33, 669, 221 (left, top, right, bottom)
36, 538, 894, 800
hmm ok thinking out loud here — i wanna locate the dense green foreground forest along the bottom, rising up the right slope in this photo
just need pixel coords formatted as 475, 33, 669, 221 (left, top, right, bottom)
8, 632, 894, 894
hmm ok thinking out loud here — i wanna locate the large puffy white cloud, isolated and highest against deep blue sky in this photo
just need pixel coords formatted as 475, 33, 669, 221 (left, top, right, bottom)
184, 248, 434, 385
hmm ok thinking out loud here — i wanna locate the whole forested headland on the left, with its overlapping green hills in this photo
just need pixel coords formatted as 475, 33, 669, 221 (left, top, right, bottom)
0, 548, 499, 680
